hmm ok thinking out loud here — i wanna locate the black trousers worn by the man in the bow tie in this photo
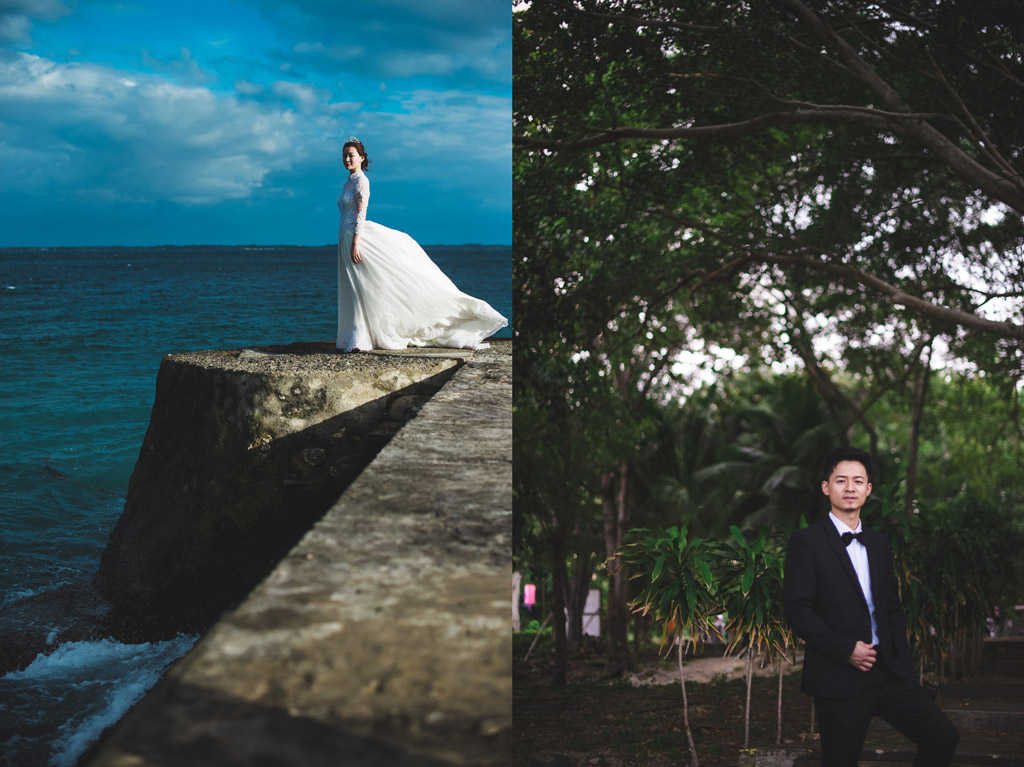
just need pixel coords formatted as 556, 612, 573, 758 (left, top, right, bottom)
814, 658, 959, 767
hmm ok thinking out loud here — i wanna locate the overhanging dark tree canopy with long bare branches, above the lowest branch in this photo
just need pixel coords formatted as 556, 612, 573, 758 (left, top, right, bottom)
515, 0, 1024, 335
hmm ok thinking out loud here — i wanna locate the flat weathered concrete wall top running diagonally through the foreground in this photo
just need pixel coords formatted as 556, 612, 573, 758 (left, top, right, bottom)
86, 342, 512, 767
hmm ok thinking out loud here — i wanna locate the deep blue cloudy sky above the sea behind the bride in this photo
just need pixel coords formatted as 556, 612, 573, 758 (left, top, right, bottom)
0, 0, 512, 246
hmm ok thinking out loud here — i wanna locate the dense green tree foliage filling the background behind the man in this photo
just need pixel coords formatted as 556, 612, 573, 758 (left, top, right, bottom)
513, 0, 1024, 684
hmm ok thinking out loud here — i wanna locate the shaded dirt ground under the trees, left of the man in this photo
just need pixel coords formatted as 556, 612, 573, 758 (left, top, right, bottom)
513, 640, 811, 767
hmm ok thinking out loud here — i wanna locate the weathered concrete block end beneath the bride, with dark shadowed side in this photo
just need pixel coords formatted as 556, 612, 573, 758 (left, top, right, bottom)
96, 344, 459, 639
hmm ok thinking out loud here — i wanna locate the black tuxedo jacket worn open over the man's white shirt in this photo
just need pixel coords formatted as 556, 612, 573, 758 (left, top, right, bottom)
782, 516, 912, 697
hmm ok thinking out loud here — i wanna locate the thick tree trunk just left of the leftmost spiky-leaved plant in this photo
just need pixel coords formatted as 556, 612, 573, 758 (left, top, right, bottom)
601, 464, 632, 677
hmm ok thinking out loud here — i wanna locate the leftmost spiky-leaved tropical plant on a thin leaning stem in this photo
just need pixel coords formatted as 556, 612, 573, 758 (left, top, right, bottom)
623, 526, 720, 767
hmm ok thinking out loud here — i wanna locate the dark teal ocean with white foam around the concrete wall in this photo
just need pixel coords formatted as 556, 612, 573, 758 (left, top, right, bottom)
0, 245, 512, 767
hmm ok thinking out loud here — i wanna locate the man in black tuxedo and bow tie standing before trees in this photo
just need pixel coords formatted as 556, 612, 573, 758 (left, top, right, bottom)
783, 448, 959, 767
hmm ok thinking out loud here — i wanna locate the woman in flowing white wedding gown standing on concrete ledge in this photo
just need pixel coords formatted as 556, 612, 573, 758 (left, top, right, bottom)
337, 137, 508, 351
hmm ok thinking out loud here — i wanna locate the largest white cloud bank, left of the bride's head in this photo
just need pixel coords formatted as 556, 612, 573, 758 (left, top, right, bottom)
0, 53, 315, 204
